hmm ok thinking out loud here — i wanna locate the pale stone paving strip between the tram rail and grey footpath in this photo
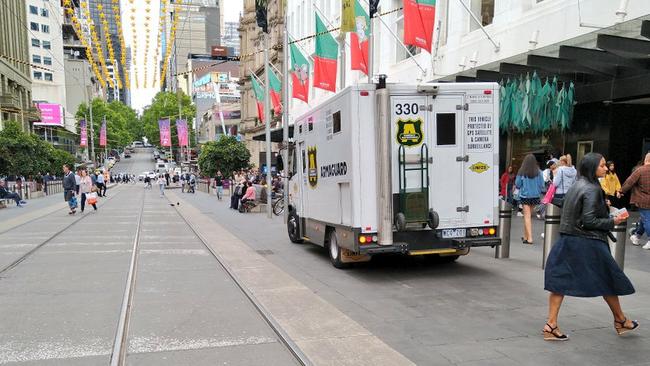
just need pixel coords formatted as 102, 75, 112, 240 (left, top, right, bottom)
167, 192, 414, 366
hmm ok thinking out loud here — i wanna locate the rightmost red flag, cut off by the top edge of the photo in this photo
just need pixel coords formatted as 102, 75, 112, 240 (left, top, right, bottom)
404, 0, 436, 53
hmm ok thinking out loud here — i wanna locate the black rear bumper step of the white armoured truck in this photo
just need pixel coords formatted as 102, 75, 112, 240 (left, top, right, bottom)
359, 231, 501, 255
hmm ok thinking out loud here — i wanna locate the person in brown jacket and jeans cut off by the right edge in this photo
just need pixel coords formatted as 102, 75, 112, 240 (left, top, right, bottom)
617, 153, 650, 249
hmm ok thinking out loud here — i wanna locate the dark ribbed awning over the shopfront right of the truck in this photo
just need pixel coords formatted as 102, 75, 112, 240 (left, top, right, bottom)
443, 16, 650, 104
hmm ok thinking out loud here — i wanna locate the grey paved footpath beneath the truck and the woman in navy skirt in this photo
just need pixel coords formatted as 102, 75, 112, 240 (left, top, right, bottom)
173, 192, 650, 365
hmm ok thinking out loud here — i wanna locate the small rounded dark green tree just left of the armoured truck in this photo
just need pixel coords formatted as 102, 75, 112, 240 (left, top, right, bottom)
199, 135, 251, 177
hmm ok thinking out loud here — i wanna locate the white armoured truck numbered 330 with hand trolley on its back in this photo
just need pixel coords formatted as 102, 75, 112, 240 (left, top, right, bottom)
287, 82, 500, 267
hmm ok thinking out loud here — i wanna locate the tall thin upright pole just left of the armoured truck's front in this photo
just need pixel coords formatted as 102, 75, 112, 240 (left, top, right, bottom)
282, 15, 289, 224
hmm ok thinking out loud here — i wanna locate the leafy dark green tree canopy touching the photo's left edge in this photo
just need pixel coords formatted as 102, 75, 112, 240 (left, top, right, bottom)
0, 121, 75, 176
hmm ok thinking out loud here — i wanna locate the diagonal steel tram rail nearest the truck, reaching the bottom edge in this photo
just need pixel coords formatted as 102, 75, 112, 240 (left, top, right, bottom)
167, 198, 312, 366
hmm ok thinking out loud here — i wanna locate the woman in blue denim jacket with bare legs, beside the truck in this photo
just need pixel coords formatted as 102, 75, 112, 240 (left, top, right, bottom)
515, 154, 544, 244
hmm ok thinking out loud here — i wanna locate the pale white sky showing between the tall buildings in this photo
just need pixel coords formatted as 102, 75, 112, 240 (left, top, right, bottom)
121, 0, 243, 112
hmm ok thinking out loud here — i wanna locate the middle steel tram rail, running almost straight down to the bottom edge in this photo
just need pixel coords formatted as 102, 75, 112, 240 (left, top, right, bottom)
111, 190, 145, 366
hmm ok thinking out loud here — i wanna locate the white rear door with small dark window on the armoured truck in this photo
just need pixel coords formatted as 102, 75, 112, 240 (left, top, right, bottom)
428, 94, 467, 228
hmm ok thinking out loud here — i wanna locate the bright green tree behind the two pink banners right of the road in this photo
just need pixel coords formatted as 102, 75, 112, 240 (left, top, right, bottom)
141, 92, 196, 146
